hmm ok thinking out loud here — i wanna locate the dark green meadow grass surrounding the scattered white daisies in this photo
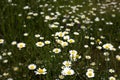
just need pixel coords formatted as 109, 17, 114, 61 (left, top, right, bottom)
0, 0, 120, 80
